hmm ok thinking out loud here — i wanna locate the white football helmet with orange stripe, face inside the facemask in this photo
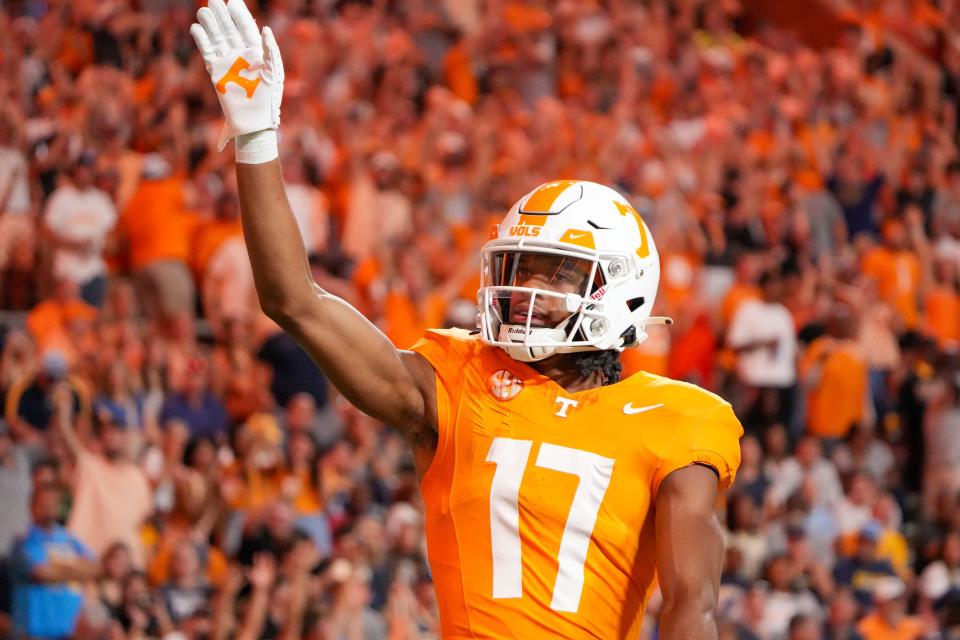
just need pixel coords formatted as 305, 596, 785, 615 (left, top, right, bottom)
478, 180, 671, 362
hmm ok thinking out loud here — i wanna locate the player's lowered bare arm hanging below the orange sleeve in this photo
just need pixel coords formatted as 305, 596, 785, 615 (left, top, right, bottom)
655, 465, 723, 640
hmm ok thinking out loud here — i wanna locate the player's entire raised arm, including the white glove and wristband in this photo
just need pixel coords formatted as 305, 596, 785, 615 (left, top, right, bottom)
191, 0, 436, 441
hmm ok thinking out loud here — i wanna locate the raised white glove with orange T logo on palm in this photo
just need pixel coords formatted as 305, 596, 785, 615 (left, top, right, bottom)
190, 0, 283, 150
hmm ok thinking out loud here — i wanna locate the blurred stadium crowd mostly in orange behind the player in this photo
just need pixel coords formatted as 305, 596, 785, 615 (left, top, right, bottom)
0, 0, 960, 640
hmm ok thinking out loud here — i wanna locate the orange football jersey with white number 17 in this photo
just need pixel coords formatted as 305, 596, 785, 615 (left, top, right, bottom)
413, 330, 743, 640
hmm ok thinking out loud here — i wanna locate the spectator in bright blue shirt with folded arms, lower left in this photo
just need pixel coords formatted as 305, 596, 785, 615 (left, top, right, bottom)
13, 485, 98, 638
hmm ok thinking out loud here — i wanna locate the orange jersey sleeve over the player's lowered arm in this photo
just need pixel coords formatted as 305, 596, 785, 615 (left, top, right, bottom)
652, 402, 743, 496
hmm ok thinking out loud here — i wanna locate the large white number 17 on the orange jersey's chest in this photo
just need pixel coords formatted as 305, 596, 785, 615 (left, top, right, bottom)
487, 438, 613, 612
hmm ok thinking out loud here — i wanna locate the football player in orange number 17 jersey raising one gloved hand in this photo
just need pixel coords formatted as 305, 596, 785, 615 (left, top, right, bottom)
191, 0, 743, 640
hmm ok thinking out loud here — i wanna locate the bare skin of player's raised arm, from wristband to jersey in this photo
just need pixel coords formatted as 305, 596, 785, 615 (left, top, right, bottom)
237, 165, 434, 433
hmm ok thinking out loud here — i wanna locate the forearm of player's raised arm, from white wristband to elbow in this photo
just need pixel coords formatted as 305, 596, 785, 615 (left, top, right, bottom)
237, 160, 314, 319
